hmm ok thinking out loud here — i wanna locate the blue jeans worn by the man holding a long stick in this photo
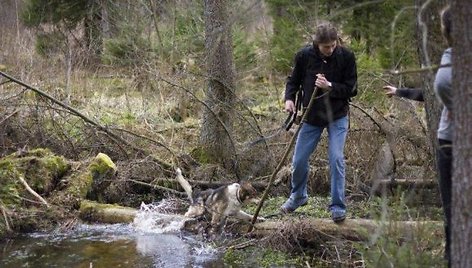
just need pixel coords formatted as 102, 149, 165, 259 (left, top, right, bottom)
289, 116, 349, 213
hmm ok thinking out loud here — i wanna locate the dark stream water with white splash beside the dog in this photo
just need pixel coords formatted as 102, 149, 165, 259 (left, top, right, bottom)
0, 202, 224, 268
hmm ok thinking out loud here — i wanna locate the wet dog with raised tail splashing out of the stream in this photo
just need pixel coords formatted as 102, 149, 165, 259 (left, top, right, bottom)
176, 168, 264, 232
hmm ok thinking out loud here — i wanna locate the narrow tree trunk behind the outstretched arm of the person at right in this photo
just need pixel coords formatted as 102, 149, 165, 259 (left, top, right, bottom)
415, 0, 446, 161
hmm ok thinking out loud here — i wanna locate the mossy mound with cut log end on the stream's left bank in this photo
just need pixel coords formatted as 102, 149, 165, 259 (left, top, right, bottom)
0, 149, 117, 238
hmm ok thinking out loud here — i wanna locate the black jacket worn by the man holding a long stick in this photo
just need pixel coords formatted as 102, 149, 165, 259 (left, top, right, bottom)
285, 45, 357, 126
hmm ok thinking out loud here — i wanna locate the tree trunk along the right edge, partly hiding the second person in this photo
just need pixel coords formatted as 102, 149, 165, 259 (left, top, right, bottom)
451, 1, 472, 267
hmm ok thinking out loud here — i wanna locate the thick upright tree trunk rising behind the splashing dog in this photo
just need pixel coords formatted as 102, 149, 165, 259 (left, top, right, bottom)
200, 0, 235, 168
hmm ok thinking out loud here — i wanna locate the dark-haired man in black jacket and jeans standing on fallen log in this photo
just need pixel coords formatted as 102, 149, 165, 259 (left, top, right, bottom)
280, 22, 357, 222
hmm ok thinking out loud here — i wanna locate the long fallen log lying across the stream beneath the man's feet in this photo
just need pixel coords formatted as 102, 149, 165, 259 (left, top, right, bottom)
74, 201, 443, 243
